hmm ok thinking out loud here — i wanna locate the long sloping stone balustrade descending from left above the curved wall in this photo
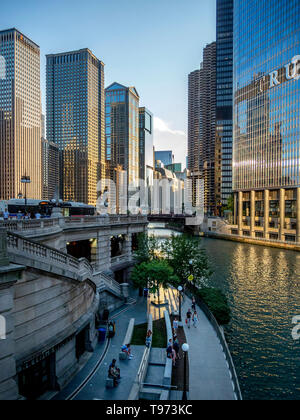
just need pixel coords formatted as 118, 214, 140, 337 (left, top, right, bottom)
7, 232, 93, 281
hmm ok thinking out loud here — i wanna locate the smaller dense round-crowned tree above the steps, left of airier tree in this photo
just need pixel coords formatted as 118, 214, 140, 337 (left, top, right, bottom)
131, 260, 180, 302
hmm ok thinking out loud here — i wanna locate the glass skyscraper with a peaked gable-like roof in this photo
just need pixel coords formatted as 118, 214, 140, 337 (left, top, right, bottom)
105, 83, 140, 185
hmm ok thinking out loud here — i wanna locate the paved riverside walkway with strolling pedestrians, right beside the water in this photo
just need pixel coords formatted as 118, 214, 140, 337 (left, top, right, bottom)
182, 296, 236, 401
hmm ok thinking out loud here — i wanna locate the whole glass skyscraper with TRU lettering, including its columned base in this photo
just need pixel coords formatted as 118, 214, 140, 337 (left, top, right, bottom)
233, 0, 300, 243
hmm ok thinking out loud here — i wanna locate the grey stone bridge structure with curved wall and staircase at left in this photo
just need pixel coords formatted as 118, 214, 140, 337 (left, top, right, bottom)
0, 216, 148, 400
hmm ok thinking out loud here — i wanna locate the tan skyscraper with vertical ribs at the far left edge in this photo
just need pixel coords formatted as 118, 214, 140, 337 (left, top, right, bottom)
0, 29, 42, 200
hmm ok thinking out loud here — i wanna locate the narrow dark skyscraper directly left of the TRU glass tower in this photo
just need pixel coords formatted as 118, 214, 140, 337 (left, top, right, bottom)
216, 0, 233, 205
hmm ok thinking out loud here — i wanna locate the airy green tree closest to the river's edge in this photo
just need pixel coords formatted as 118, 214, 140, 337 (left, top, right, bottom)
162, 235, 212, 287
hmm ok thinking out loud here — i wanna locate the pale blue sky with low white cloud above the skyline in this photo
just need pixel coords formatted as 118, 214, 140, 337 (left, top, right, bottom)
0, 0, 216, 166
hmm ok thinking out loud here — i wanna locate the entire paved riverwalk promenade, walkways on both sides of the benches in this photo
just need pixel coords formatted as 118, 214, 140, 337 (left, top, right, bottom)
53, 289, 236, 400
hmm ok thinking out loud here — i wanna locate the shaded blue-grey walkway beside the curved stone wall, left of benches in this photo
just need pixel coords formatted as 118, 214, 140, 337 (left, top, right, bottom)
54, 292, 147, 400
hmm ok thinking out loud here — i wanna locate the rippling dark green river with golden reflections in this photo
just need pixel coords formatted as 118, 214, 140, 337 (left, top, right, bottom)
150, 226, 300, 400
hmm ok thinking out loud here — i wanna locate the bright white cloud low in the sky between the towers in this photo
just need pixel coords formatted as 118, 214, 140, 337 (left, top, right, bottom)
154, 117, 187, 168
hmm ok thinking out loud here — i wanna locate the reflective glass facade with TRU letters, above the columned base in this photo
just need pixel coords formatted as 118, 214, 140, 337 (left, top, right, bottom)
233, 0, 300, 191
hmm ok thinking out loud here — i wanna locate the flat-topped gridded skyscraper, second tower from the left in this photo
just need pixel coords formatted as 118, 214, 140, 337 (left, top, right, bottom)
46, 49, 105, 205
